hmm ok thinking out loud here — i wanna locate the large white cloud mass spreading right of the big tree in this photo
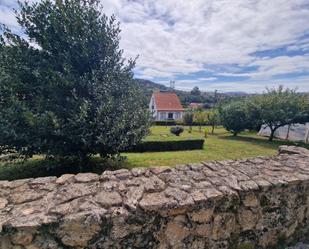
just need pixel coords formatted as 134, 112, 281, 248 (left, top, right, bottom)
103, 0, 309, 80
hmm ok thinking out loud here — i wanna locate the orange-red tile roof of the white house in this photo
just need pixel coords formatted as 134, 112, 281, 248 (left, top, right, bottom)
153, 92, 184, 111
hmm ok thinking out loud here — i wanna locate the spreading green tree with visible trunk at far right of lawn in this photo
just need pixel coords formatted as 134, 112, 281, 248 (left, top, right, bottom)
253, 86, 309, 141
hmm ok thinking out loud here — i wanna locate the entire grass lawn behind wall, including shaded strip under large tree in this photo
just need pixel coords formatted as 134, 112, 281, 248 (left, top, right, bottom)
0, 126, 309, 180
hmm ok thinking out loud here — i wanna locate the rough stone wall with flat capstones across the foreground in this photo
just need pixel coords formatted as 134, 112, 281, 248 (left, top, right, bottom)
0, 147, 309, 249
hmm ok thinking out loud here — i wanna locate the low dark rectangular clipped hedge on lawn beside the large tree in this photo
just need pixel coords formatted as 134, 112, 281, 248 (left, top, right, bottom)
128, 139, 204, 152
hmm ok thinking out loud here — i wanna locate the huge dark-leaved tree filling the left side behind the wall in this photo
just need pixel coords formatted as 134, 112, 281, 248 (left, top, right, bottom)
0, 0, 150, 165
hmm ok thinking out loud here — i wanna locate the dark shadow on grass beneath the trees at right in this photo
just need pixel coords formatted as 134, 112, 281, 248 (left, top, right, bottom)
218, 135, 309, 149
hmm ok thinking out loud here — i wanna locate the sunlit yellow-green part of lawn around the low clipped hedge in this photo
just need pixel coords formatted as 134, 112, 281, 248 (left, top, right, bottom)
124, 126, 309, 168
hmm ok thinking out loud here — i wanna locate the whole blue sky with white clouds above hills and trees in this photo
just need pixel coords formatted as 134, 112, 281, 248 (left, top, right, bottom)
0, 0, 309, 92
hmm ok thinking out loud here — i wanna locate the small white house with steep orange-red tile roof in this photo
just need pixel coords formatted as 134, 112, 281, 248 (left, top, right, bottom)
149, 92, 184, 121
